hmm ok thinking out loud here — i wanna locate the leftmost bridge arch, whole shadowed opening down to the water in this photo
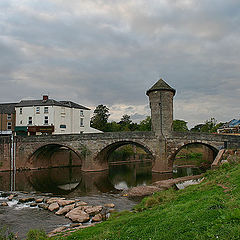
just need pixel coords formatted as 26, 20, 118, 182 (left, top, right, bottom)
27, 143, 83, 169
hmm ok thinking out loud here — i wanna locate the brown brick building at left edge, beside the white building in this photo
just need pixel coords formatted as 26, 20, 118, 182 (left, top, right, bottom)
0, 103, 16, 135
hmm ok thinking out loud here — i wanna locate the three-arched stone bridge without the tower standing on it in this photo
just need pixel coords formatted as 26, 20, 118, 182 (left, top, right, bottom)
0, 129, 240, 172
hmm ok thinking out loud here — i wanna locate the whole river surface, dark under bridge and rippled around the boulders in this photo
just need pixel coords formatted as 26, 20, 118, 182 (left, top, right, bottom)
0, 162, 206, 239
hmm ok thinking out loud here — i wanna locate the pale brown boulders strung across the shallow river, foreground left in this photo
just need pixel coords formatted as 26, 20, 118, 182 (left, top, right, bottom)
0, 192, 115, 237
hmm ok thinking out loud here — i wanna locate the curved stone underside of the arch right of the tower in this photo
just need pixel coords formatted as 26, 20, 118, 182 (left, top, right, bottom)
168, 141, 219, 169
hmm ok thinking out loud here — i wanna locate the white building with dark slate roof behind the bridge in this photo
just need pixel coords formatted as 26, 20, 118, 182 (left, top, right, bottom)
15, 95, 101, 135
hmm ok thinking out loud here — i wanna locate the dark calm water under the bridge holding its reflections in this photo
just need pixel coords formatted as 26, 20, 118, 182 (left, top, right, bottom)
0, 162, 208, 197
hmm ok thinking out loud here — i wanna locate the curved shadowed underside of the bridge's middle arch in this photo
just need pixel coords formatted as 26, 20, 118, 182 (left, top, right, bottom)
95, 140, 155, 165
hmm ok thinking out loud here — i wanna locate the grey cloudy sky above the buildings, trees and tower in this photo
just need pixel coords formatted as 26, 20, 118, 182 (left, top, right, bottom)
0, 0, 240, 127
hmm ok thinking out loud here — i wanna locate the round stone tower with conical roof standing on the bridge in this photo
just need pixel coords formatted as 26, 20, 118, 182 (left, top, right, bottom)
146, 79, 176, 136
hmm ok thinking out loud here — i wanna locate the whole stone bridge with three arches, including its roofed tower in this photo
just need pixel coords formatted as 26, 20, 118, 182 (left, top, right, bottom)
0, 79, 240, 172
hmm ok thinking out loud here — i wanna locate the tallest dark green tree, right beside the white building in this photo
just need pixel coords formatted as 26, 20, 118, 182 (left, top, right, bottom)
91, 104, 110, 131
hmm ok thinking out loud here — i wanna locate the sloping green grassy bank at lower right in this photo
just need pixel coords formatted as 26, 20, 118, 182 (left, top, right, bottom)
51, 164, 240, 240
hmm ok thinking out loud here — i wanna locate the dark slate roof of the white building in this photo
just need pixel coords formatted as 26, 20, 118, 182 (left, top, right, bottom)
16, 99, 90, 110
